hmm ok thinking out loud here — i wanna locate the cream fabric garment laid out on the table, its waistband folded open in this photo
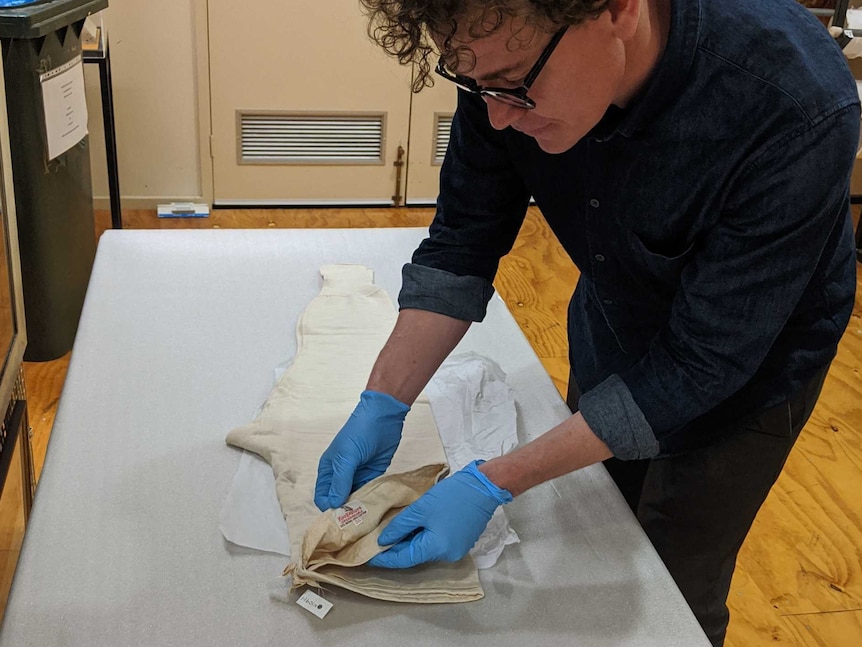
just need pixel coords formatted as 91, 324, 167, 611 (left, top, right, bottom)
227, 265, 484, 602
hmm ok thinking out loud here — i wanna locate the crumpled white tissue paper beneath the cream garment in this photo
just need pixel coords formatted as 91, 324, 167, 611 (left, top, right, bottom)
219, 353, 520, 569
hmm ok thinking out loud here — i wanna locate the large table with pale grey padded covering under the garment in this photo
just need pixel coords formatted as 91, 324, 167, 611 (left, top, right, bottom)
0, 229, 708, 647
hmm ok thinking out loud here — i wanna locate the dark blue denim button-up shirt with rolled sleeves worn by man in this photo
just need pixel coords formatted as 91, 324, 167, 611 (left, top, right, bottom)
399, 0, 860, 459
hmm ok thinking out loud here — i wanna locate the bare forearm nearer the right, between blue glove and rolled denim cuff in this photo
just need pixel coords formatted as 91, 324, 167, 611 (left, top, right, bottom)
479, 412, 613, 496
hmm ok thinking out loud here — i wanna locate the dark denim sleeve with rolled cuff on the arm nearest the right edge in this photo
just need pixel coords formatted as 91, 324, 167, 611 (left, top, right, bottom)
579, 104, 859, 459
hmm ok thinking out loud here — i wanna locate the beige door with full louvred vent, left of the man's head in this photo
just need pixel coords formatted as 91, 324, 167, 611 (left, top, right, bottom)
208, 0, 411, 205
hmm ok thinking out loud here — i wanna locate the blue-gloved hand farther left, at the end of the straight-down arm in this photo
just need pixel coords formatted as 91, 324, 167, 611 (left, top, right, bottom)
314, 391, 410, 510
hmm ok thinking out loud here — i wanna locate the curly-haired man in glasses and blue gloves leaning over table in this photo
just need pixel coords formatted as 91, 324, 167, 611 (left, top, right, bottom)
315, 0, 860, 645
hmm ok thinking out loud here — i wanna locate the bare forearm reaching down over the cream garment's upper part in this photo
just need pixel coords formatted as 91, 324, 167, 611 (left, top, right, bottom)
366, 309, 470, 404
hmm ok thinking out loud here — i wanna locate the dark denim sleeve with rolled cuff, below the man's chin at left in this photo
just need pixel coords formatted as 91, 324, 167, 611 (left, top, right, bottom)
398, 90, 530, 321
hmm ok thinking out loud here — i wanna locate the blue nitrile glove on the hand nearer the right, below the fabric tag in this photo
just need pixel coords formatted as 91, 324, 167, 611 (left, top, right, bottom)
368, 461, 512, 568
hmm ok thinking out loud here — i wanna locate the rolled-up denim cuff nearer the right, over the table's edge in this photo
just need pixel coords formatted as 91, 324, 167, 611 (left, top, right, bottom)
578, 374, 659, 461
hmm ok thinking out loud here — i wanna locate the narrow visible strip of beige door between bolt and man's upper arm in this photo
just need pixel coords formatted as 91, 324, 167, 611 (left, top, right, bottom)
407, 73, 458, 205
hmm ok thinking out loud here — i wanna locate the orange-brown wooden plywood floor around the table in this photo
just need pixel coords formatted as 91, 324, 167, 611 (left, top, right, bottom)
0, 209, 862, 647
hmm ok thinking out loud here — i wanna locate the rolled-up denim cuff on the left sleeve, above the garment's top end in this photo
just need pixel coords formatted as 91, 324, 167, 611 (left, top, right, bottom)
398, 263, 494, 321
